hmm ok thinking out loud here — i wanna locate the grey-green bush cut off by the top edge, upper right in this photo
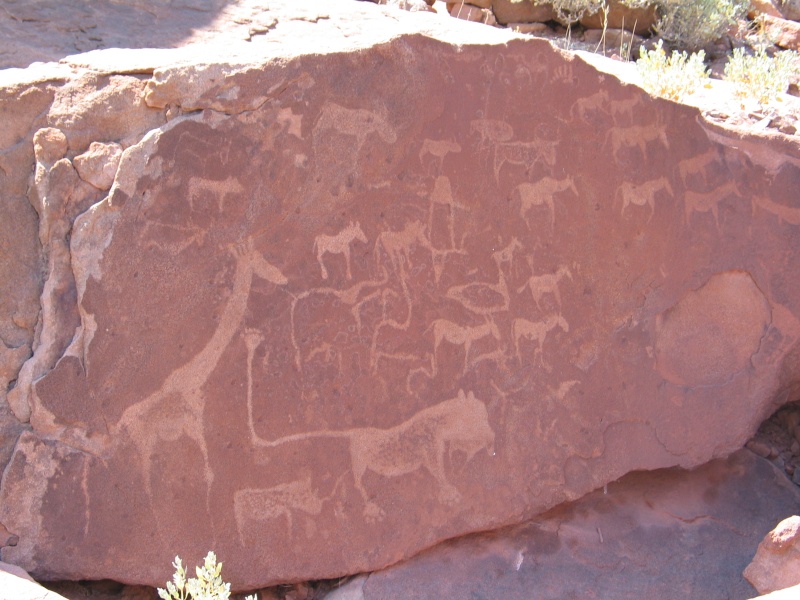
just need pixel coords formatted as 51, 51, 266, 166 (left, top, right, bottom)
655, 0, 750, 50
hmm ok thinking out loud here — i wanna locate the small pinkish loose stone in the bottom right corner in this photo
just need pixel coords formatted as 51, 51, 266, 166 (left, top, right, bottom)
744, 515, 800, 594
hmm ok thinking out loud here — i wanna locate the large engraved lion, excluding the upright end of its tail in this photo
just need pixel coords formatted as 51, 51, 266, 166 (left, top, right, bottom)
244, 390, 495, 520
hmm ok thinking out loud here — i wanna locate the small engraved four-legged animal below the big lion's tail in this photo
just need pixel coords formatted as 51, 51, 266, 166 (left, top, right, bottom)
233, 477, 328, 546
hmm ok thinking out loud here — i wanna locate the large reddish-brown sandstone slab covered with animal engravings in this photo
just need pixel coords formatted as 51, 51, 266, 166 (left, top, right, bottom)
0, 0, 800, 589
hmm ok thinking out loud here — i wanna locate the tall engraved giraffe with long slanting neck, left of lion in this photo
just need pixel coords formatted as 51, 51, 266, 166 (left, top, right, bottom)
112, 238, 287, 508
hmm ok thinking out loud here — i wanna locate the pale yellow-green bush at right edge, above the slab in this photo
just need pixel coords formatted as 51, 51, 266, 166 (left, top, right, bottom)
724, 48, 797, 106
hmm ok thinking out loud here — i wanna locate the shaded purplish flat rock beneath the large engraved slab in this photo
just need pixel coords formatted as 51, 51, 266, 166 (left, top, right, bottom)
348, 451, 800, 600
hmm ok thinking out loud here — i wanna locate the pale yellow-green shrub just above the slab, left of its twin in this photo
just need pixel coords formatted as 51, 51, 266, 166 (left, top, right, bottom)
636, 40, 708, 100
